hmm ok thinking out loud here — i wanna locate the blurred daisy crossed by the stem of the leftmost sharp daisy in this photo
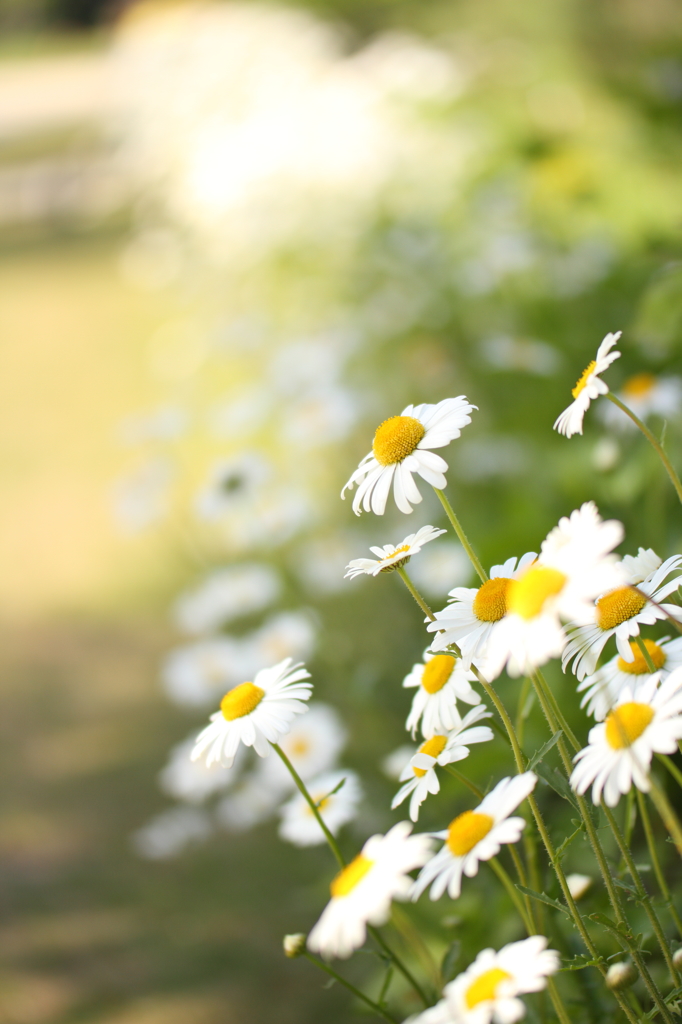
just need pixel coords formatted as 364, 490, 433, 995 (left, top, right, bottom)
280, 768, 363, 846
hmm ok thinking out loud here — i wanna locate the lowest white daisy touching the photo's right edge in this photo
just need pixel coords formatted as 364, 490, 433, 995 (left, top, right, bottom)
570, 669, 682, 807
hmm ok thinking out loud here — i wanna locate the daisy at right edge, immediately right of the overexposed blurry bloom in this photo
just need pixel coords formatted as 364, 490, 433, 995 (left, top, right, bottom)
561, 555, 682, 679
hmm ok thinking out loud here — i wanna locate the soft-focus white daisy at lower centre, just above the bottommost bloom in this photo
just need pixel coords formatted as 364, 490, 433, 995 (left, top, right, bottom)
308, 821, 431, 957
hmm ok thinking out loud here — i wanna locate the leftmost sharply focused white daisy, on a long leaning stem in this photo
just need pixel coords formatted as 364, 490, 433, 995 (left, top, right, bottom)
191, 657, 312, 768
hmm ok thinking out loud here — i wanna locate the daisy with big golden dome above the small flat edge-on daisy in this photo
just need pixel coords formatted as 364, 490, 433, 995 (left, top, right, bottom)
341, 394, 476, 515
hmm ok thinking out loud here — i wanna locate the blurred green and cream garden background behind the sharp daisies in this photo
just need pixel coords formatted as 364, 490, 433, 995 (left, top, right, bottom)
0, 0, 682, 1024
